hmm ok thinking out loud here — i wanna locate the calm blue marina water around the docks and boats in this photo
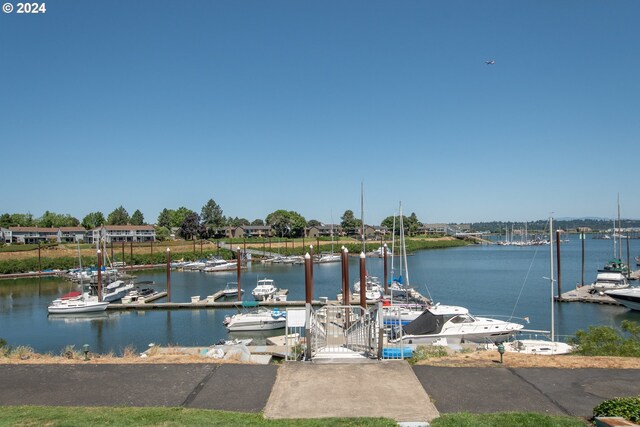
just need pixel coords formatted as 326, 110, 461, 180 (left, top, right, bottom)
0, 236, 640, 354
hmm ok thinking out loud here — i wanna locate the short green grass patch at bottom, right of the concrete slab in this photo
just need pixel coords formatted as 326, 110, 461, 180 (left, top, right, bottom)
431, 412, 590, 427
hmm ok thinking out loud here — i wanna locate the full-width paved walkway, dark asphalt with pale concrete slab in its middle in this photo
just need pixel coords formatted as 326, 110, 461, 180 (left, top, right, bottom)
0, 361, 640, 421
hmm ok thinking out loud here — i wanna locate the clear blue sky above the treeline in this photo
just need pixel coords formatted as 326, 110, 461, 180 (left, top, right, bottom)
0, 0, 640, 223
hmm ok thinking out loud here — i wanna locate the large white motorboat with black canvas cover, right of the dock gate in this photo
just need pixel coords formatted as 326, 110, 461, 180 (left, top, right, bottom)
389, 304, 524, 344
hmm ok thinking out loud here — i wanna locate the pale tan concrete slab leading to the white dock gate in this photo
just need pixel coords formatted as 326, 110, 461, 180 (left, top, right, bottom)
264, 361, 438, 422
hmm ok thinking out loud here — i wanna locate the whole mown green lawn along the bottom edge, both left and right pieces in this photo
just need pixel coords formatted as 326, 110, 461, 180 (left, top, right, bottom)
0, 406, 589, 427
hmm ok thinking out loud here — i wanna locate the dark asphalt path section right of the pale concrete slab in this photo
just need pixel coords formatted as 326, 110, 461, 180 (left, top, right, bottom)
413, 366, 640, 417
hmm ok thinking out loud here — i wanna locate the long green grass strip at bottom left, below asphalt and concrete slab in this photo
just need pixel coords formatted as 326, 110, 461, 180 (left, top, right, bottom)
0, 406, 396, 427
